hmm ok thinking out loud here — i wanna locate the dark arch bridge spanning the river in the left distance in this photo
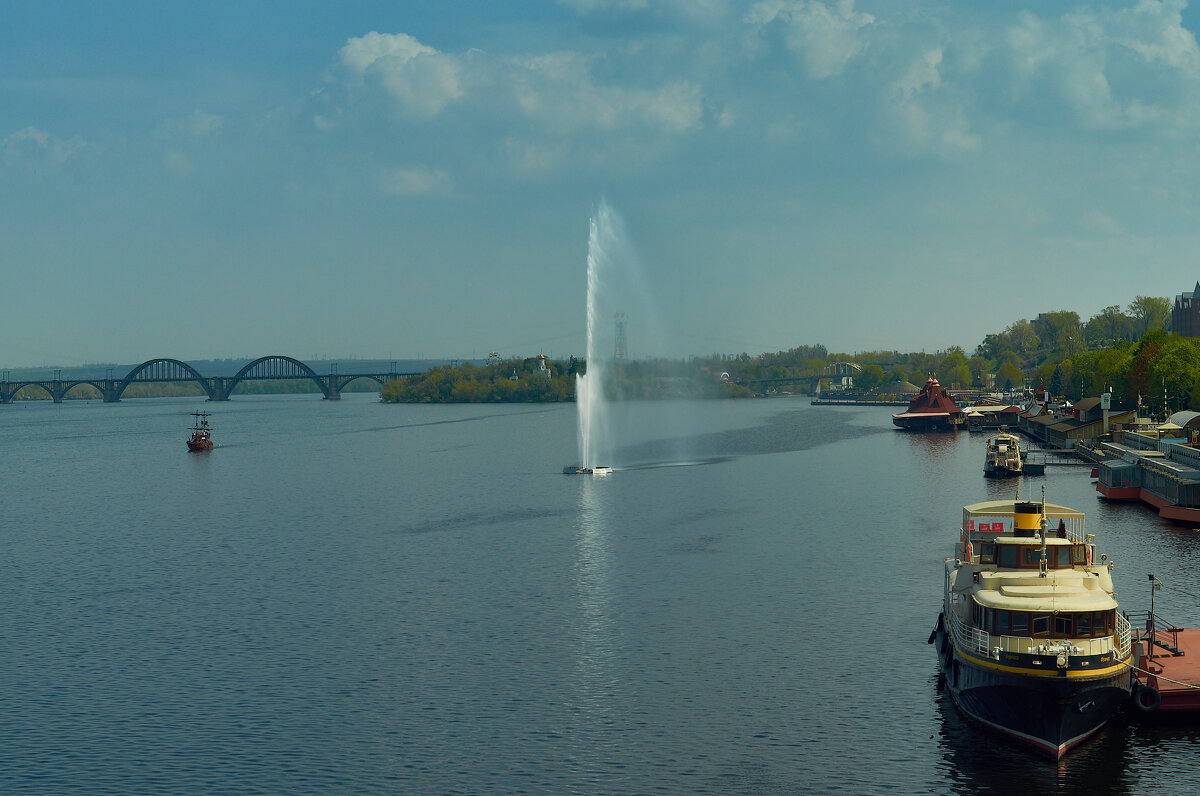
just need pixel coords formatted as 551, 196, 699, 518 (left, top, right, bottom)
0, 354, 418, 403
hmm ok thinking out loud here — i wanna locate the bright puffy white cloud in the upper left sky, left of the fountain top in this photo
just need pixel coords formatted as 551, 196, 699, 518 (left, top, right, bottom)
338, 31, 463, 118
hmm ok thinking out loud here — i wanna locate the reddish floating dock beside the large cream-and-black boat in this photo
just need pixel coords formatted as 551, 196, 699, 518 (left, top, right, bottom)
1129, 614, 1200, 716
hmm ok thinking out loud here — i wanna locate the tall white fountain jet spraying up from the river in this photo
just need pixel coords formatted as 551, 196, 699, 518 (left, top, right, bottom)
563, 202, 620, 475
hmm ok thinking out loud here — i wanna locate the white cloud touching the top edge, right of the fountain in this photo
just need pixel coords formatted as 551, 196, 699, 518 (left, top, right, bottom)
743, 0, 875, 80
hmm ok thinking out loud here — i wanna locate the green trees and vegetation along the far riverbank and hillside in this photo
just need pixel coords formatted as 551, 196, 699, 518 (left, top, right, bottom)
17, 295, 1200, 412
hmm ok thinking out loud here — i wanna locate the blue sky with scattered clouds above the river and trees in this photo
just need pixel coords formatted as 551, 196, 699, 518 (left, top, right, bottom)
7, 0, 1200, 367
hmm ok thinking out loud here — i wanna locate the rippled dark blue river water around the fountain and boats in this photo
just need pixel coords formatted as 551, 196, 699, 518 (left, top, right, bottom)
0, 394, 1200, 795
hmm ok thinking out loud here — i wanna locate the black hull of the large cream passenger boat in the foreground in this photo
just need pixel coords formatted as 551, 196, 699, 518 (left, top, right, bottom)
936, 629, 1130, 760
